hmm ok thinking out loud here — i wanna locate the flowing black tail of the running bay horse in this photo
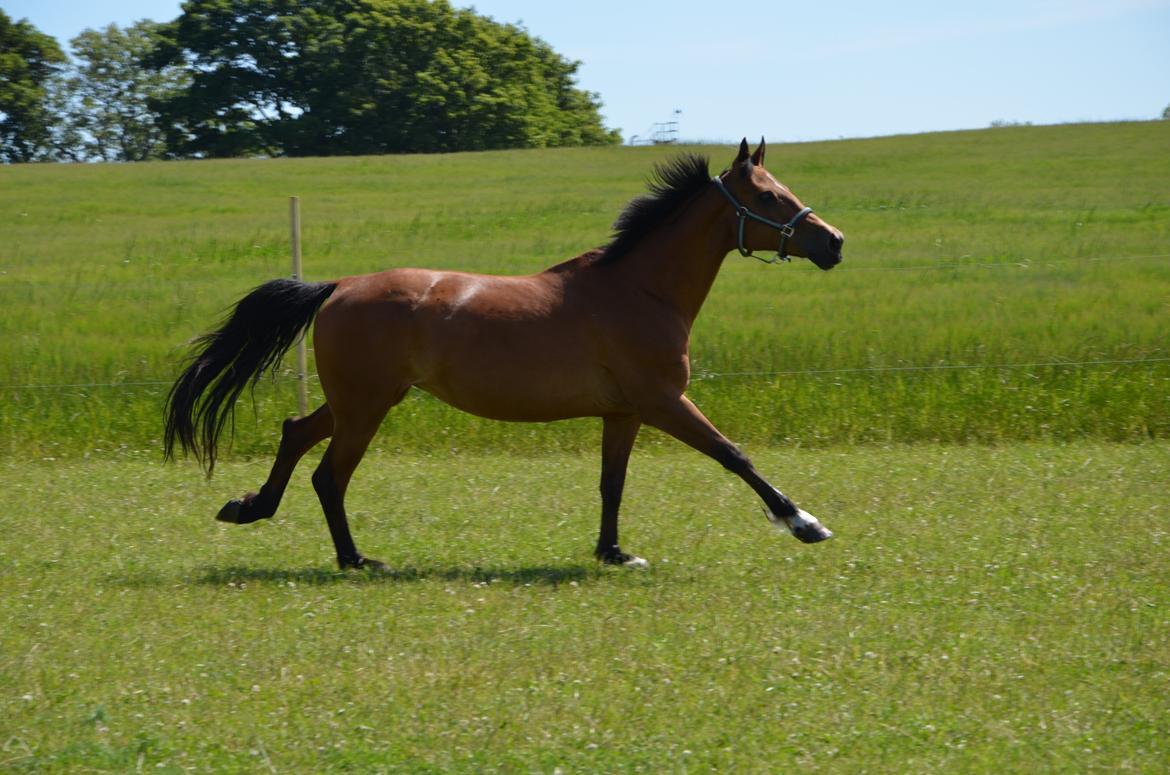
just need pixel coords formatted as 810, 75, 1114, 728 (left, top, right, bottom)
164, 280, 337, 476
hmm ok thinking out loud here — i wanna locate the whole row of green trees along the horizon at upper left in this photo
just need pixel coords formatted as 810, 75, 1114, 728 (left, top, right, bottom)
0, 0, 620, 163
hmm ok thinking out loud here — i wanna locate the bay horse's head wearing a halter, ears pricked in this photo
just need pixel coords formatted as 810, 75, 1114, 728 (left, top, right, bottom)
715, 138, 845, 269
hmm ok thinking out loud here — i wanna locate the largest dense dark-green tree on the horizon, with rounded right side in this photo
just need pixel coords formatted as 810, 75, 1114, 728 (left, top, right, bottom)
156, 0, 620, 156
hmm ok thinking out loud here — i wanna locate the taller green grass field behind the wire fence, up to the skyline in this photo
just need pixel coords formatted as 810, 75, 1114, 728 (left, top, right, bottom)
0, 122, 1170, 457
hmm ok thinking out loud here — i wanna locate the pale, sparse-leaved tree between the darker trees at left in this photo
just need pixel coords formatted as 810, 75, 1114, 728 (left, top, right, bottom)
54, 20, 191, 162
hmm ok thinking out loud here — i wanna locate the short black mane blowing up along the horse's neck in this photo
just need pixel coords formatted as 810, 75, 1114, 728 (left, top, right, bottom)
598, 153, 711, 262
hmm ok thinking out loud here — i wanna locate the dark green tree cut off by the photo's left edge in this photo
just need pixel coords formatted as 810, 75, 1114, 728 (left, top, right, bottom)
0, 11, 66, 163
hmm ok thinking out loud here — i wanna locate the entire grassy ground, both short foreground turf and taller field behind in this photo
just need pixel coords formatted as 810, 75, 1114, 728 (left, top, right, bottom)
0, 122, 1170, 773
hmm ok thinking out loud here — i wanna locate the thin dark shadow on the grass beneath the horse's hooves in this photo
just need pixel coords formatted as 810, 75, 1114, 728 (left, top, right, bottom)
194, 565, 601, 587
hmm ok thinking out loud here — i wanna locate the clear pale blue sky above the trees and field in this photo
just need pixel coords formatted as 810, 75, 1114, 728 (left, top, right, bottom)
9, 0, 1170, 143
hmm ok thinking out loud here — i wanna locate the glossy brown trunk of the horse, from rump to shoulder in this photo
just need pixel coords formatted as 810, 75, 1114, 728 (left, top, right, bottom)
315, 264, 617, 420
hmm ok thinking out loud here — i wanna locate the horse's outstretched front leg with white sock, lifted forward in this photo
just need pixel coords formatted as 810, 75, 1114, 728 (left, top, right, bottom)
642, 396, 833, 543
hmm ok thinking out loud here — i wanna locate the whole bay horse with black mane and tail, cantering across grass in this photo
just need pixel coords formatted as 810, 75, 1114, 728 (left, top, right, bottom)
164, 139, 844, 569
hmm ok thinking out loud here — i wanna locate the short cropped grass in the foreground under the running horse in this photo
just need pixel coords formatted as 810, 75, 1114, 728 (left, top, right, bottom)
0, 447, 1170, 773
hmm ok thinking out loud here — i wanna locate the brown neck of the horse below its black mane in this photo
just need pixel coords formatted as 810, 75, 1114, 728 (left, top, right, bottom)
621, 188, 734, 329
